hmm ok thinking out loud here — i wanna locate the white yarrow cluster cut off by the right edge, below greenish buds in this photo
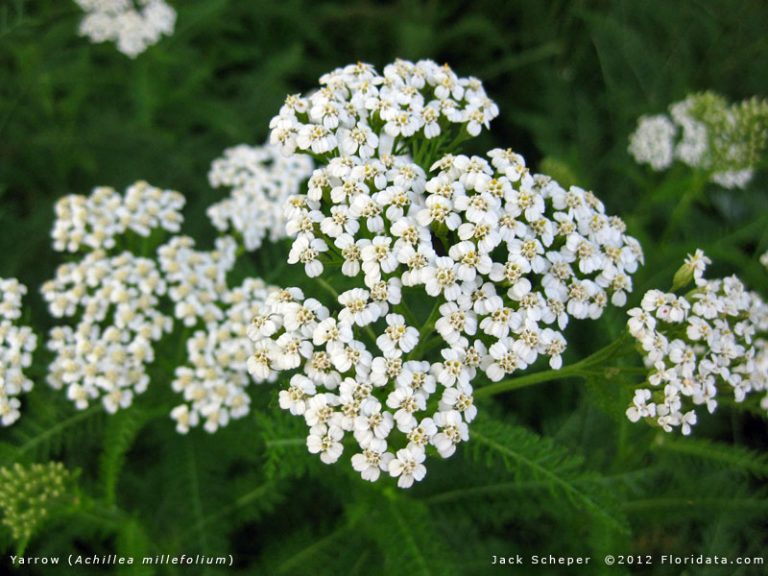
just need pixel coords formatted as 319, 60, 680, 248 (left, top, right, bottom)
627, 251, 768, 435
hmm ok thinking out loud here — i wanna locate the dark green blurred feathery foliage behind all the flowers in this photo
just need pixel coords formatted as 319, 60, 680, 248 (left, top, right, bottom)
0, 0, 768, 574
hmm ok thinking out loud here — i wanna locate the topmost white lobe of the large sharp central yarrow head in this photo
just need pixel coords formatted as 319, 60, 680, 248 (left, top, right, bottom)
270, 60, 499, 159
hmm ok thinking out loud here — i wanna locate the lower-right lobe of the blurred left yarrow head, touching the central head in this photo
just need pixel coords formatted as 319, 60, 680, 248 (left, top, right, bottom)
171, 278, 277, 434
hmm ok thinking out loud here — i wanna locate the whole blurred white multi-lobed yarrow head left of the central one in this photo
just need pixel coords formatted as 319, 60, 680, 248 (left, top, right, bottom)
42, 183, 276, 433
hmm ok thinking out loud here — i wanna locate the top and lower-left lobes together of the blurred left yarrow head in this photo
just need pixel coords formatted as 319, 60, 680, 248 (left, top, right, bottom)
42, 182, 184, 413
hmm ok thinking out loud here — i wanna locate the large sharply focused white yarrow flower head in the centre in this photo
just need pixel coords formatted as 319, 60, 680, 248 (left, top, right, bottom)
249, 61, 642, 487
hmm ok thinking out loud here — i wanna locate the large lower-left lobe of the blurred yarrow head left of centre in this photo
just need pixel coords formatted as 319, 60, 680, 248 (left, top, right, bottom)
42, 250, 172, 413
